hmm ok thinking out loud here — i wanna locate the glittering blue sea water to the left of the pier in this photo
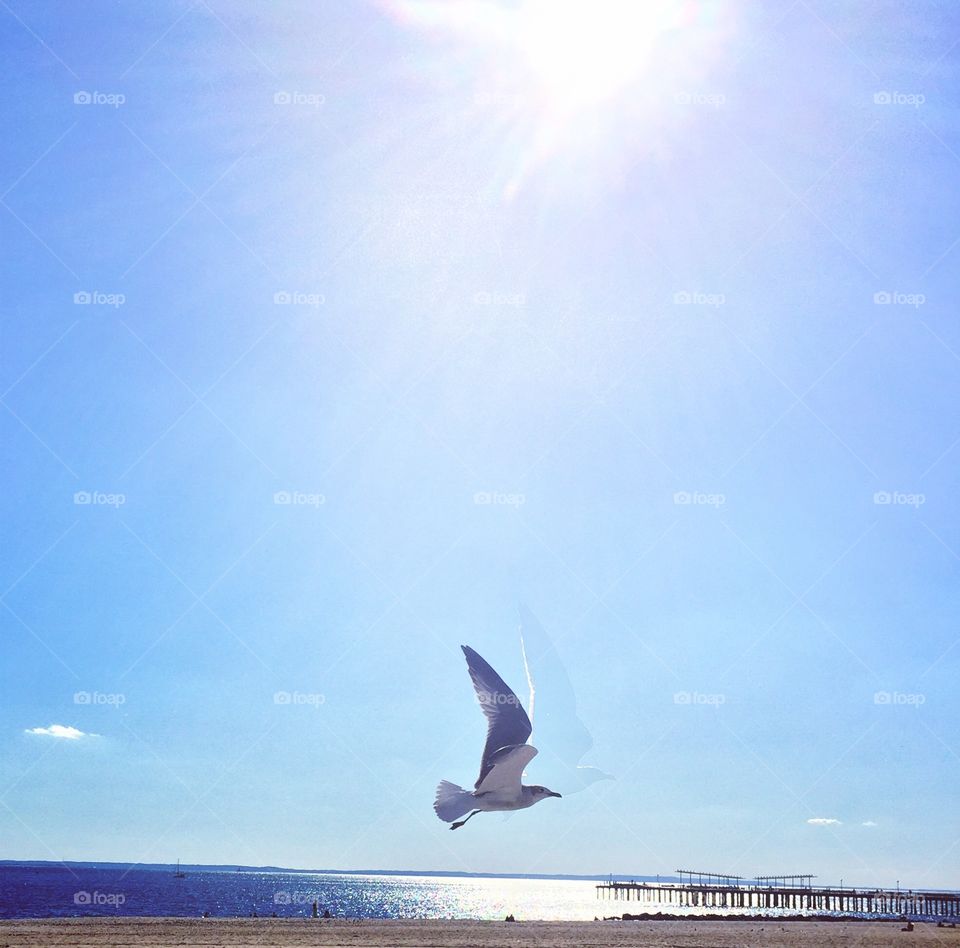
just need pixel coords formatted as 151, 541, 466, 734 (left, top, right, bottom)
0, 865, 609, 920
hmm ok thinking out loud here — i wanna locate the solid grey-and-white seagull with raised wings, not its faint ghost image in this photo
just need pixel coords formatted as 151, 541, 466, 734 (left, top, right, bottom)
433, 645, 560, 829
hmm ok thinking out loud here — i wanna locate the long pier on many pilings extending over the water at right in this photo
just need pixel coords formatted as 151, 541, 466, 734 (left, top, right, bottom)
597, 869, 960, 920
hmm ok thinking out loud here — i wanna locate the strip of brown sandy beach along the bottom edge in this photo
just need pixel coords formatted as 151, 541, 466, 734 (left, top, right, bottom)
0, 918, 960, 948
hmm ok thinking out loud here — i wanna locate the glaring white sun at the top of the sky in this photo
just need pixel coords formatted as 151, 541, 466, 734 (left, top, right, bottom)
382, 0, 739, 198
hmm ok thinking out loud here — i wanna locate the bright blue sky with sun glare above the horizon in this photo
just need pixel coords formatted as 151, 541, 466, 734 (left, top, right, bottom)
0, 0, 960, 886
